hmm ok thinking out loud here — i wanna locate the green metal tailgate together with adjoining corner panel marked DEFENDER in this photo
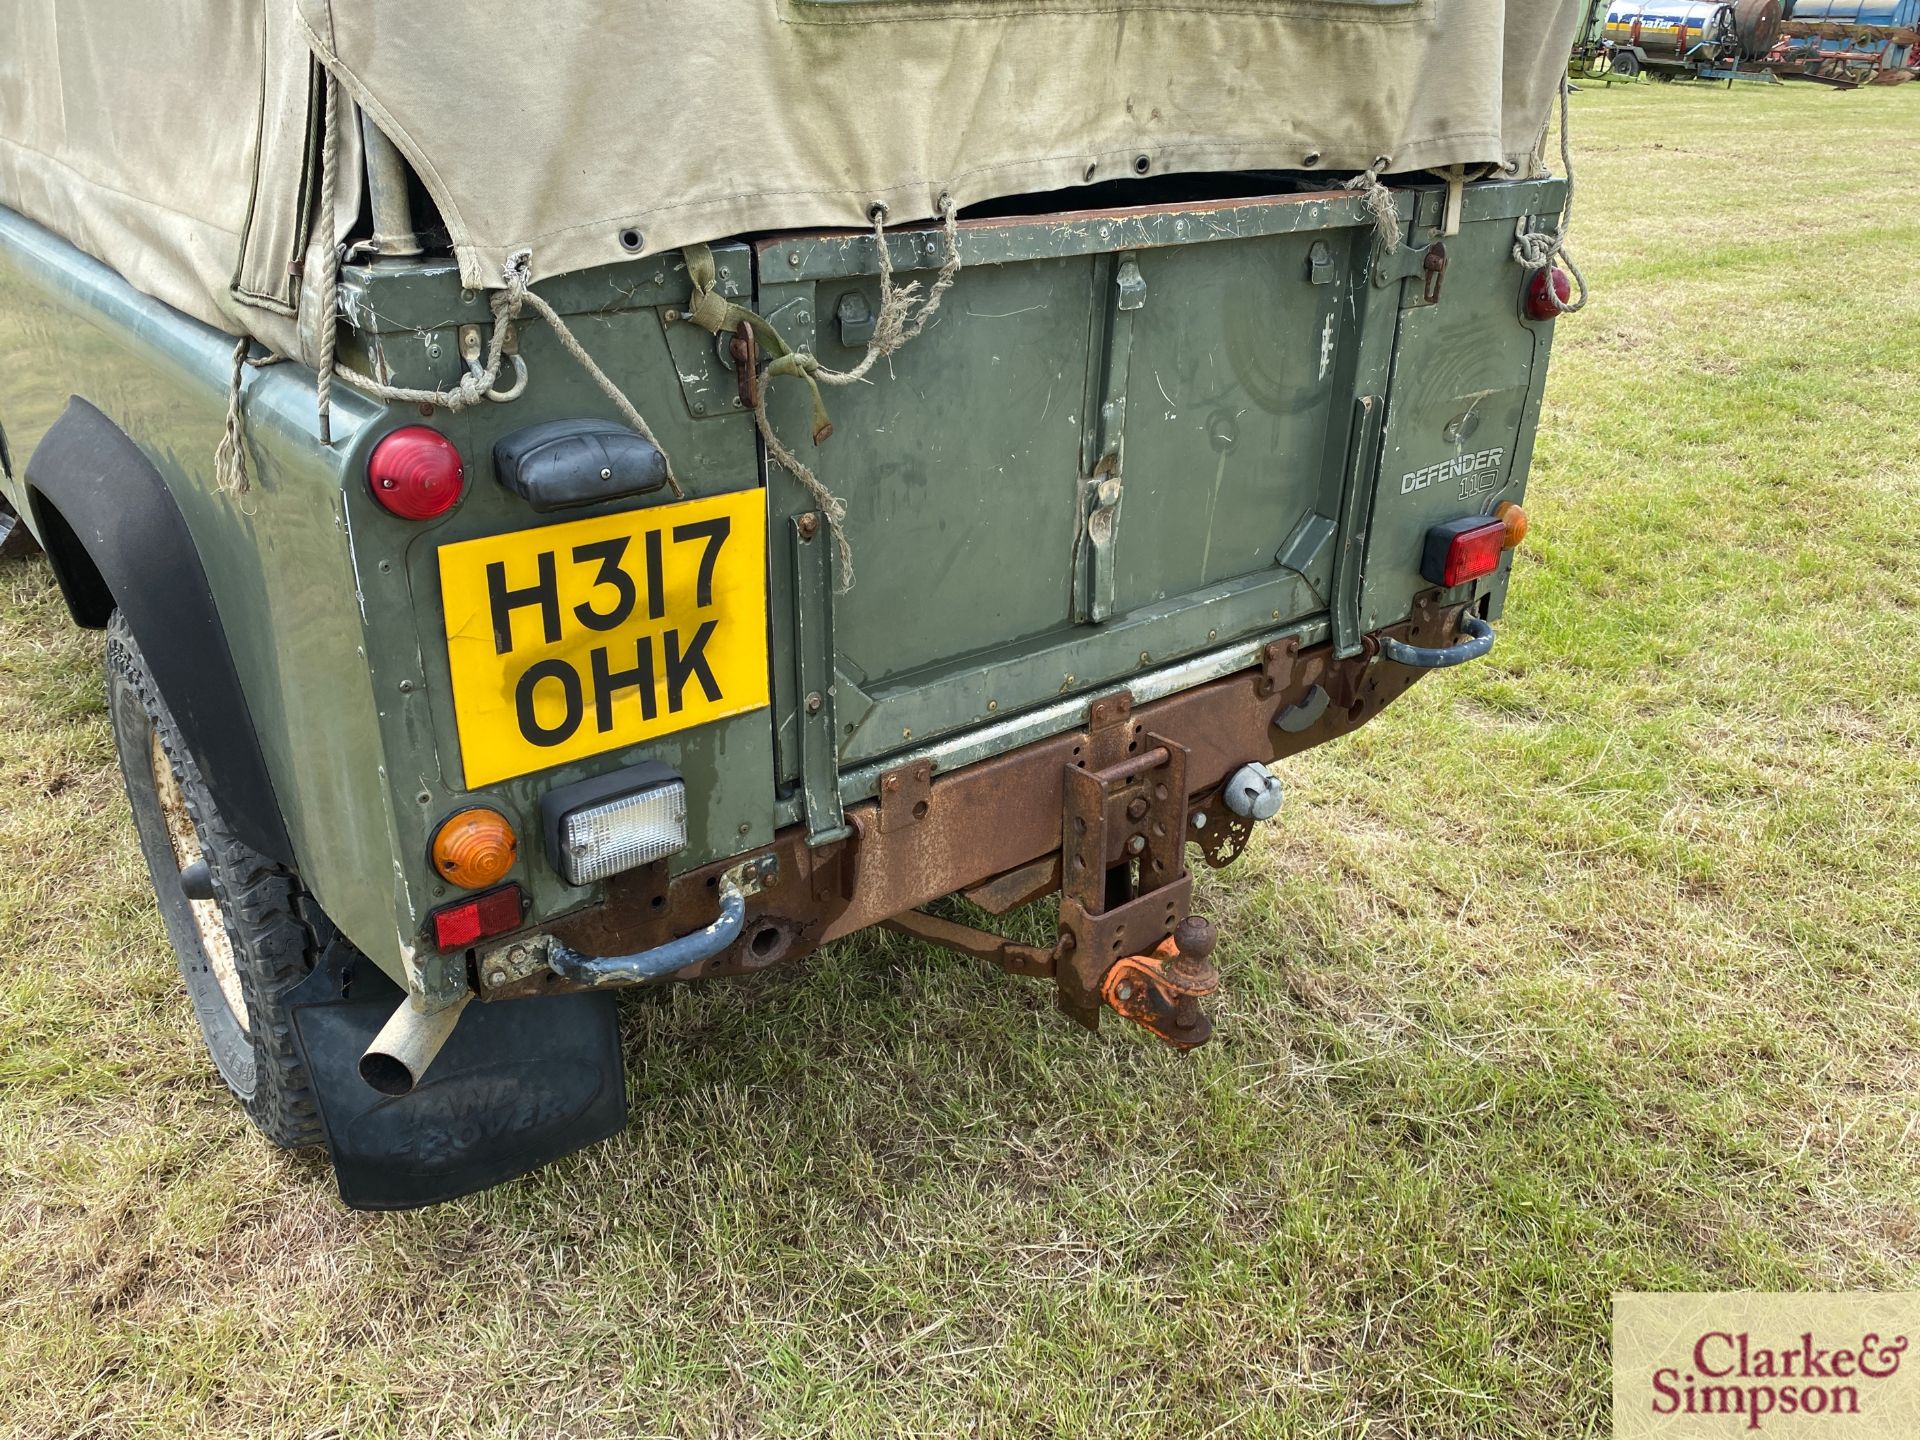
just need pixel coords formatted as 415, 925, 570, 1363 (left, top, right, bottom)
756, 182, 1559, 828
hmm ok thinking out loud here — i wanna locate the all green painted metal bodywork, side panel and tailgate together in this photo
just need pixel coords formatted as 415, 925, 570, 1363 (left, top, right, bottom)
0, 182, 1561, 1000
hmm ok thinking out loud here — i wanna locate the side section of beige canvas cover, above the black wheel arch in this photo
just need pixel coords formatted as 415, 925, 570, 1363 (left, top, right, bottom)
0, 0, 361, 353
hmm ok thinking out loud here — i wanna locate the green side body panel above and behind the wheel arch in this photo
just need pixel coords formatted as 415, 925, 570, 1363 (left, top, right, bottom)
0, 209, 413, 975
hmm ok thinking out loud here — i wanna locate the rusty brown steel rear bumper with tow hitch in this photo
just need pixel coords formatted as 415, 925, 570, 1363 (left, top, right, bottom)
474, 595, 1463, 1048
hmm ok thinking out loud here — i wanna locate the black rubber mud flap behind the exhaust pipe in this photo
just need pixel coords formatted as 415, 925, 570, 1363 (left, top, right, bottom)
288, 947, 626, 1210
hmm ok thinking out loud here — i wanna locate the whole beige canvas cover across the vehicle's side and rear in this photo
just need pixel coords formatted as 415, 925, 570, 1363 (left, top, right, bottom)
0, 0, 1578, 353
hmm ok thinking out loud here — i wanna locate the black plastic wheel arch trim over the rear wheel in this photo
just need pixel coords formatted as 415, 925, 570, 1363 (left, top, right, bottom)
25, 396, 294, 866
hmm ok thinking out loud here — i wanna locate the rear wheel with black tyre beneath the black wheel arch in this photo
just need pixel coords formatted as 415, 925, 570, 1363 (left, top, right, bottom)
106, 611, 332, 1148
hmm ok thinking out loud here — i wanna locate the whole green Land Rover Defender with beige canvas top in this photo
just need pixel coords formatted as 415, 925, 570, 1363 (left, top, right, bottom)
0, 0, 1584, 1208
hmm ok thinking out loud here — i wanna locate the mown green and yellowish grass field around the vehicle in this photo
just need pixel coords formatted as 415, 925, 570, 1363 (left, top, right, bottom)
0, 84, 1920, 1440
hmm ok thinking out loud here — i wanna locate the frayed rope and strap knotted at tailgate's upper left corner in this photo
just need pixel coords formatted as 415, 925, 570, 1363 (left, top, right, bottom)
682, 194, 960, 595
